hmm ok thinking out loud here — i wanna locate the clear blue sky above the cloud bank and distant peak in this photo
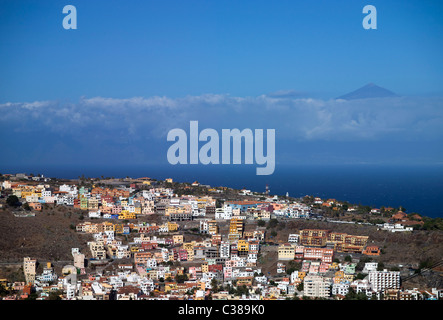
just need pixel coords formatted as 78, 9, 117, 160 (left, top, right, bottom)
0, 0, 443, 102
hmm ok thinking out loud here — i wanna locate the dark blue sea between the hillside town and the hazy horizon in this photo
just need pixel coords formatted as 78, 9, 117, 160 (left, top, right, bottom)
0, 164, 443, 218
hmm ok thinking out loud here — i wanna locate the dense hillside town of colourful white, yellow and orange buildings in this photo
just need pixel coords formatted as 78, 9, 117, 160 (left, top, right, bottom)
0, 175, 443, 300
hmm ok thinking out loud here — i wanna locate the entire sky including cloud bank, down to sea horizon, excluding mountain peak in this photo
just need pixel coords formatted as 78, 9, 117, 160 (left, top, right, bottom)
0, 0, 443, 170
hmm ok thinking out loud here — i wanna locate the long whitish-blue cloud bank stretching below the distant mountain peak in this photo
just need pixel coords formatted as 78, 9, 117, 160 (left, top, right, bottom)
0, 94, 443, 141
